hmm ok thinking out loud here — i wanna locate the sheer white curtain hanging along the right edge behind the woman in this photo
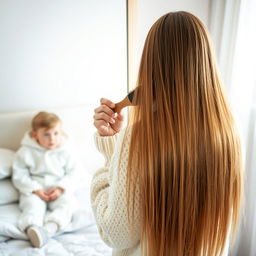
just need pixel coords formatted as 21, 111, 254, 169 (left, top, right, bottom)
210, 0, 256, 256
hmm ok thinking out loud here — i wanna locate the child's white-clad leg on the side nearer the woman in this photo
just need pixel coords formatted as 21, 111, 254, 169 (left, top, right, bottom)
45, 193, 73, 232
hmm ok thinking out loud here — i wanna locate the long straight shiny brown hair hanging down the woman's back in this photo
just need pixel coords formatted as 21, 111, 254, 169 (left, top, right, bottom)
127, 12, 242, 256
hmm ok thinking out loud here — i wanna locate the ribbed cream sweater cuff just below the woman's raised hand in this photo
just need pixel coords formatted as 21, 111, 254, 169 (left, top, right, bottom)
94, 132, 118, 160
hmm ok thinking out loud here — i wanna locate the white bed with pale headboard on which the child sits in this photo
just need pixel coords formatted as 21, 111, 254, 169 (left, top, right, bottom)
0, 105, 111, 256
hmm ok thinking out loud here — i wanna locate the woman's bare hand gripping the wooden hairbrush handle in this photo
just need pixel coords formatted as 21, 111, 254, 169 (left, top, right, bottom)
93, 98, 124, 136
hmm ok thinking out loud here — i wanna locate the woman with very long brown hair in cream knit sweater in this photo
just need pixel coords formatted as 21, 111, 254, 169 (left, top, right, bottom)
91, 12, 243, 256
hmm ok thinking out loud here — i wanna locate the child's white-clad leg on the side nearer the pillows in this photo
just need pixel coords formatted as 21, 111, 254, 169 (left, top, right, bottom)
18, 194, 47, 231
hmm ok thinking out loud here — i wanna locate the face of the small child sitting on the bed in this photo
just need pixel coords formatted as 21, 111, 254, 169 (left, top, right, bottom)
32, 124, 61, 149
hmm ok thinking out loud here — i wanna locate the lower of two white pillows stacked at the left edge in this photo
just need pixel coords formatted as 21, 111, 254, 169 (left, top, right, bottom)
0, 179, 19, 205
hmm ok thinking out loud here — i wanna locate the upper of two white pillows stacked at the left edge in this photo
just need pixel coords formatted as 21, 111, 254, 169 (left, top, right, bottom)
0, 148, 15, 180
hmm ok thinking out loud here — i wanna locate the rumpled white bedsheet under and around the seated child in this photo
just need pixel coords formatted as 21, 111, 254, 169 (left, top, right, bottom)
0, 204, 111, 256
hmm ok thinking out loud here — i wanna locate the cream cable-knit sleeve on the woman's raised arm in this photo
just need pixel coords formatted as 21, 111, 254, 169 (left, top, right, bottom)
91, 128, 140, 252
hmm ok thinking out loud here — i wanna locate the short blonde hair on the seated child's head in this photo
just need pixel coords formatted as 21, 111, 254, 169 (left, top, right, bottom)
32, 111, 61, 132
